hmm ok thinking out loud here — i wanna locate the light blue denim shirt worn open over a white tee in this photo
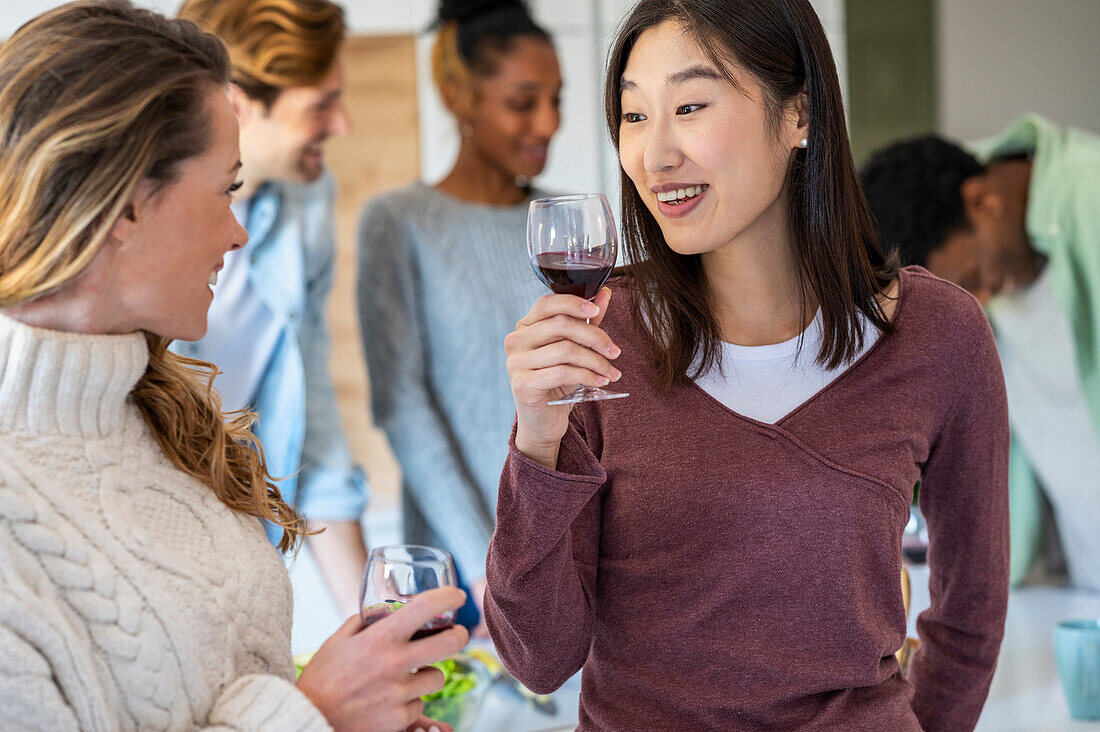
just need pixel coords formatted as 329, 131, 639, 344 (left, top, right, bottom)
172, 173, 367, 543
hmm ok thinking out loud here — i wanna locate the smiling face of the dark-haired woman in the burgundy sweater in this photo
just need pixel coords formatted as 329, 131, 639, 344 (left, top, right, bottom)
618, 21, 805, 254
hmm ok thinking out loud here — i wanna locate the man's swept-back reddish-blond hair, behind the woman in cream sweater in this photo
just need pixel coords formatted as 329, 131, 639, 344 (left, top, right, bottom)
179, 0, 347, 108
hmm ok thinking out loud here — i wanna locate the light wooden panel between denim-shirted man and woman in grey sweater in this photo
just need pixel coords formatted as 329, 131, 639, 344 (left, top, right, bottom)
326, 35, 420, 511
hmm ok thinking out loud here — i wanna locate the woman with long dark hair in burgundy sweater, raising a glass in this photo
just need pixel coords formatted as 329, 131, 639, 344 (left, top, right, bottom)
485, 0, 1008, 730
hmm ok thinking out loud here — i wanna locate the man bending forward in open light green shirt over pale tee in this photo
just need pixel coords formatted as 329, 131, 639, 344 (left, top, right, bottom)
860, 114, 1100, 590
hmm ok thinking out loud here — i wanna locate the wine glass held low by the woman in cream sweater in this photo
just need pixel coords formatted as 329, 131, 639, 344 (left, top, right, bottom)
359, 544, 455, 641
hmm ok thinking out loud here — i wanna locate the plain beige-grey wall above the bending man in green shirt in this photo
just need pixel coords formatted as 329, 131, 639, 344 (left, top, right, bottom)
936, 0, 1100, 140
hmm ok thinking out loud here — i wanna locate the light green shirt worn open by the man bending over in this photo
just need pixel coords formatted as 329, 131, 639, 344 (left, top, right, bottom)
971, 114, 1100, 582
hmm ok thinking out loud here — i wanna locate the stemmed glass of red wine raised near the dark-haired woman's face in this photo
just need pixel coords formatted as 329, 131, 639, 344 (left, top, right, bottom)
527, 193, 628, 404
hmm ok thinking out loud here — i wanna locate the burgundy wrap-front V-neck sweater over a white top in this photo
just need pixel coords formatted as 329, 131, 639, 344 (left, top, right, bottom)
485, 267, 1009, 732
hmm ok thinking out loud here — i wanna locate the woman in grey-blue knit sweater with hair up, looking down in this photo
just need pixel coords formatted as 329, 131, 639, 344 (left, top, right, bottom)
359, 0, 561, 620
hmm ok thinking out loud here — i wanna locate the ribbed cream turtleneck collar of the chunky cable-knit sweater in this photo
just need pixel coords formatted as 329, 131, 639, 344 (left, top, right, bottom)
0, 313, 149, 439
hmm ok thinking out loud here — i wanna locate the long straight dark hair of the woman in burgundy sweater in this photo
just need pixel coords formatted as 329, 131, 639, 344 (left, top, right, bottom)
604, 0, 898, 389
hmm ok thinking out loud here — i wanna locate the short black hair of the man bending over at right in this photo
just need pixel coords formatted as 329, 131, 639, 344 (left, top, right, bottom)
859, 134, 986, 266
